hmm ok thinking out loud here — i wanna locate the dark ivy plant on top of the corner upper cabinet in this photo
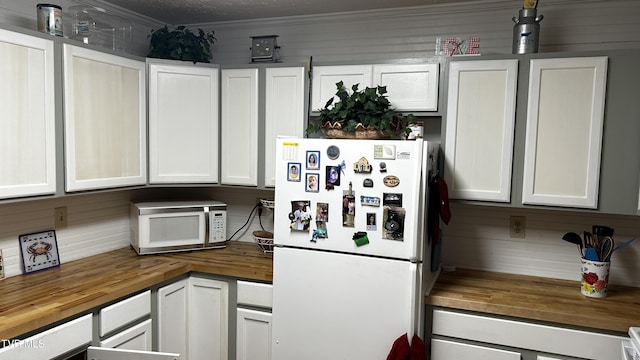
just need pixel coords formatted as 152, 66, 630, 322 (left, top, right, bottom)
147, 25, 216, 64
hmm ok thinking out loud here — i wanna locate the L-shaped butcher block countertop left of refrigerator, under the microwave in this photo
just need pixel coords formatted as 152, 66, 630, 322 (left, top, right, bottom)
0, 242, 273, 339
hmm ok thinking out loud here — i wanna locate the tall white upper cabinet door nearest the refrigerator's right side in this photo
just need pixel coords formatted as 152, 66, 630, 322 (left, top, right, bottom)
445, 60, 518, 202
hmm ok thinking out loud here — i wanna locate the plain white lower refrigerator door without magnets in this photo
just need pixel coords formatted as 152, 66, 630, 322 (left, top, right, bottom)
272, 248, 422, 360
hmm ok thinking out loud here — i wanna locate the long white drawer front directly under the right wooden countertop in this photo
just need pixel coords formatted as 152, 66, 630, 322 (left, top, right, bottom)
433, 309, 624, 360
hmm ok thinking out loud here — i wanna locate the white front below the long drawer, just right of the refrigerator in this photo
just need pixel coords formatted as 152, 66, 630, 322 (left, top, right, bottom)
431, 339, 520, 360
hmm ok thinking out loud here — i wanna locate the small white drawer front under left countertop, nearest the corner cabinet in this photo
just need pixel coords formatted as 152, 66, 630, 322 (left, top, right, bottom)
100, 290, 151, 336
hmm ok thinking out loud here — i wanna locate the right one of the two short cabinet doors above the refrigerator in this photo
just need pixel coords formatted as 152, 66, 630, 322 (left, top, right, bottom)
373, 63, 439, 111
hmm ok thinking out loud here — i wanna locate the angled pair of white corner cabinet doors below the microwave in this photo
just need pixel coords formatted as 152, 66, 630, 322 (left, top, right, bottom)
157, 277, 229, 360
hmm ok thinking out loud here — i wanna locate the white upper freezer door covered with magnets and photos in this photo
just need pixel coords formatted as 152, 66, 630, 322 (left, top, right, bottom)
274, 138, 425, 261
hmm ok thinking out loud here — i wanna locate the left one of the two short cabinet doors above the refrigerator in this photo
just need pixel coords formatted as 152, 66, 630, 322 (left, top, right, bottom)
310, 65, 373, 111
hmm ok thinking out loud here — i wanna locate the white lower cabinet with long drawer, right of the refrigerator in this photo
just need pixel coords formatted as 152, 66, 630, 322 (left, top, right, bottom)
431, 309, 625, 360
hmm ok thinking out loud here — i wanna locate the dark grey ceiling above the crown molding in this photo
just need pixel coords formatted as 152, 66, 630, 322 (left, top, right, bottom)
101, 0, 468, 25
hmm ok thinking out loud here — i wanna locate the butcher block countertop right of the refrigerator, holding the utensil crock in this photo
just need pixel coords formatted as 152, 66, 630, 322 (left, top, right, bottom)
426, 269, 640, 333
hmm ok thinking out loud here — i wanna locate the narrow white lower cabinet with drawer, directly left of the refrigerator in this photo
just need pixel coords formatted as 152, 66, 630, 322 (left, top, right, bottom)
236, 281, 273, 360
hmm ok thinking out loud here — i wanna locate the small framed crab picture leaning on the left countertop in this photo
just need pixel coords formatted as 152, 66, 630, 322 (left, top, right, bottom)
18, 230, 60, 274
